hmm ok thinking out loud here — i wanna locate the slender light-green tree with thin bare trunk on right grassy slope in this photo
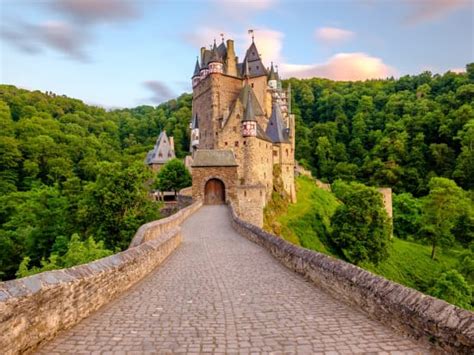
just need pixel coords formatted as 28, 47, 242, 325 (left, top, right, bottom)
421, 177, 465, 259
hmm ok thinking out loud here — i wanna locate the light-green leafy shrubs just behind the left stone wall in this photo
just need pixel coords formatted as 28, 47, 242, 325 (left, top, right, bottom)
16, 234, 112, 277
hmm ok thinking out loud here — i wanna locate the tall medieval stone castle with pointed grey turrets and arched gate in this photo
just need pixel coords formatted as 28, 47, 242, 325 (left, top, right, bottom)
190, 38, 296, 226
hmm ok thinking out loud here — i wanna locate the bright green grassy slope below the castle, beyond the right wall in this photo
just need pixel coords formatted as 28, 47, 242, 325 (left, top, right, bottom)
266, 177, 459, 298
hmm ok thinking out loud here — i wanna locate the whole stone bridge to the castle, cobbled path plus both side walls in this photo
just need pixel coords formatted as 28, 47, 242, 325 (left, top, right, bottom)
0, 205, 474, 354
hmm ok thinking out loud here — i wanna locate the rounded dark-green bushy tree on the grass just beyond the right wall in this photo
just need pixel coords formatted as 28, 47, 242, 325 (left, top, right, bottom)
331, 180, 391, 264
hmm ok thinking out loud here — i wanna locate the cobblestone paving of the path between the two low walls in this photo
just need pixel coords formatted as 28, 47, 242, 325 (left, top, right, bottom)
37, 206, 429, 354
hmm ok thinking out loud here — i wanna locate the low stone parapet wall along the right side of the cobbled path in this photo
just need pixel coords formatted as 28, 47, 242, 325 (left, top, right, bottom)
228, 204, 474, 354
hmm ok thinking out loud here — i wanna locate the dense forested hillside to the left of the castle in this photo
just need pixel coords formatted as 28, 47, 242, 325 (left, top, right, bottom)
0, 85, 191, 280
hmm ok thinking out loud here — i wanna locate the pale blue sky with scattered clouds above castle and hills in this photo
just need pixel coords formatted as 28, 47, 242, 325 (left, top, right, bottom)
0, 0, 474, 108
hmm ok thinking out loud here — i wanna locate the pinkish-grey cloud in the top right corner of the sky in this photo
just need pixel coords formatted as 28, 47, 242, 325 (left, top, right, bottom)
405, 0, 474, 25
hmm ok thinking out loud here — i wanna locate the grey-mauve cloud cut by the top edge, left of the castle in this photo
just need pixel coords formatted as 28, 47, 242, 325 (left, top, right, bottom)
48, 0, 139, 23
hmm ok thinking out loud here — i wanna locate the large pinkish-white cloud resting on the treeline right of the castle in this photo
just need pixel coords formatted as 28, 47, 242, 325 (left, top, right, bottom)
280, 53, 396, 81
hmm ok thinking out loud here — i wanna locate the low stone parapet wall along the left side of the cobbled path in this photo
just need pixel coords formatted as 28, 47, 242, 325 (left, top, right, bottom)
0, 202, 201, 354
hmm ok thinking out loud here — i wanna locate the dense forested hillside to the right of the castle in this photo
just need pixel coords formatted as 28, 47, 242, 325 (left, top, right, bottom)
284, 63, 474, 197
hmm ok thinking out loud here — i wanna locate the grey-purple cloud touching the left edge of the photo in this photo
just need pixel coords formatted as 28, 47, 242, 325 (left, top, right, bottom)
0, 21, 90, 61
